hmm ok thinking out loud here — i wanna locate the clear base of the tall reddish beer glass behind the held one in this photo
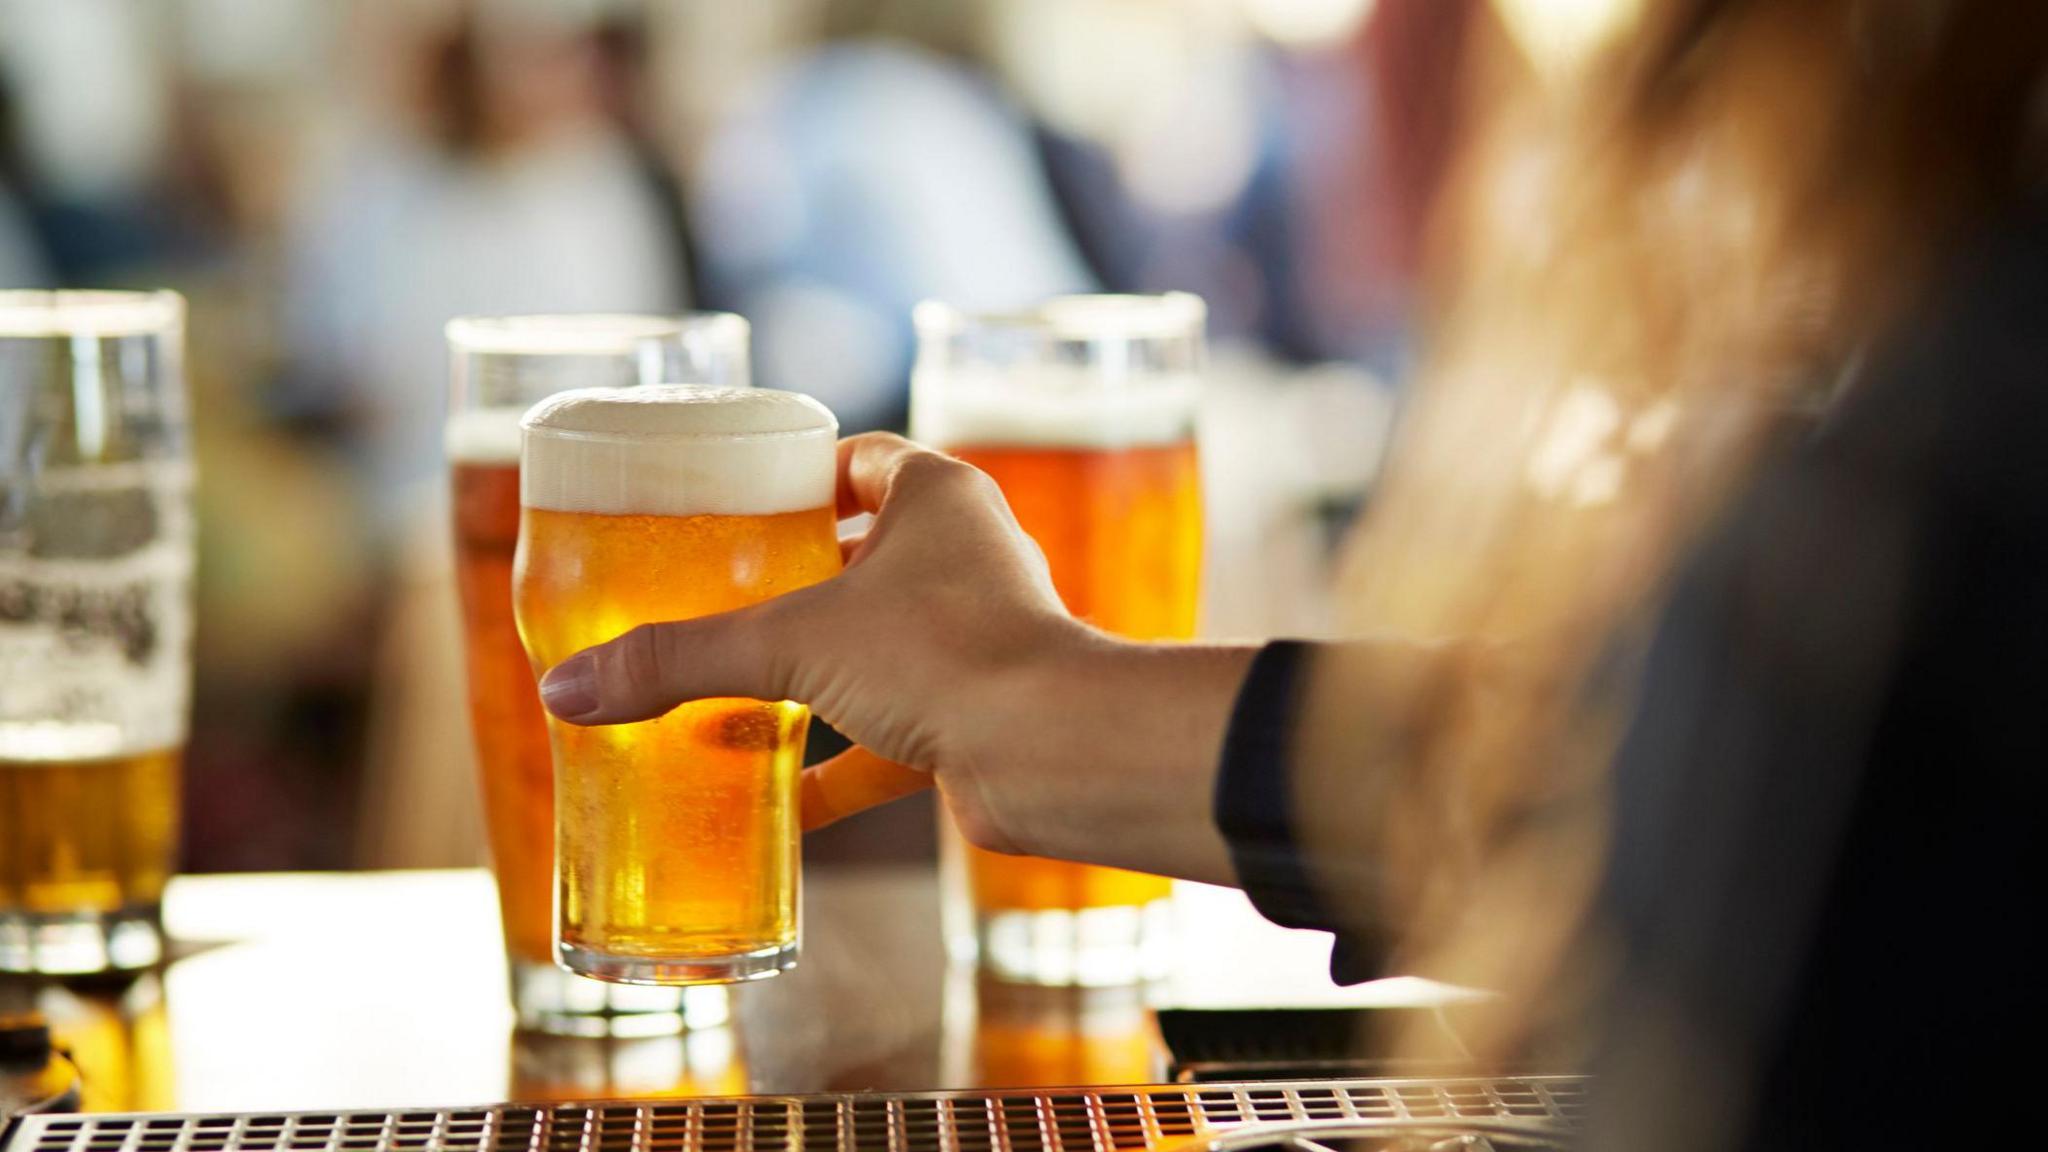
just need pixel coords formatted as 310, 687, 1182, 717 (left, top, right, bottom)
512, 959, 733, 1039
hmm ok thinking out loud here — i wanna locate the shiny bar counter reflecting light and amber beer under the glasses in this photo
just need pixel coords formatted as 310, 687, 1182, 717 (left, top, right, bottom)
12, 867, 1456, 1111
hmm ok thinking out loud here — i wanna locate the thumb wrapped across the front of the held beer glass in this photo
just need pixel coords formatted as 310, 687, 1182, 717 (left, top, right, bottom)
541, 592, 801, 726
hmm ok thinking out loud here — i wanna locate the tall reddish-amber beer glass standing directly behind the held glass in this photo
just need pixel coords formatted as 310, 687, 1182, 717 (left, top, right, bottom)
446, 314, 748, 1035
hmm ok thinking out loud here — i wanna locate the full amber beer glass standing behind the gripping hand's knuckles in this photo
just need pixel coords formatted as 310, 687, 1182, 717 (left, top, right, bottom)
911, 293, 1204, 984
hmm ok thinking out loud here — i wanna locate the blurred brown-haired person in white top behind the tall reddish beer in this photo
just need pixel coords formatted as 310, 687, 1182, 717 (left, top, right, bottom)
287, 0, 690, 531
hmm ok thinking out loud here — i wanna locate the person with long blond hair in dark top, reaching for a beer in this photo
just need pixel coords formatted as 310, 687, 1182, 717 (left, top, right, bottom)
543, 0, 2048, 1148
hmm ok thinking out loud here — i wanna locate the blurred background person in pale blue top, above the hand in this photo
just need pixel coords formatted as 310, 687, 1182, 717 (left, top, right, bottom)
694, 0, 1098, 430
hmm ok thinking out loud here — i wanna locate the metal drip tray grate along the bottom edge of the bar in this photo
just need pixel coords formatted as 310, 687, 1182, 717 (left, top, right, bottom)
0, 1076, 1585, 1152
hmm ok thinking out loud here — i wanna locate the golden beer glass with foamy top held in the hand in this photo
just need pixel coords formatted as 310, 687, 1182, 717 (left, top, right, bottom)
512, 387, 840, 984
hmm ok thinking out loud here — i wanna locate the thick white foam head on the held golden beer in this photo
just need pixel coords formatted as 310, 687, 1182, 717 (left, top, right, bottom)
520, 383, 840, 517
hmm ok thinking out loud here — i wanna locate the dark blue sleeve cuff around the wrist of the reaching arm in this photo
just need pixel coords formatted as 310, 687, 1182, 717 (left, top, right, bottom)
1217, 640, 1384, 984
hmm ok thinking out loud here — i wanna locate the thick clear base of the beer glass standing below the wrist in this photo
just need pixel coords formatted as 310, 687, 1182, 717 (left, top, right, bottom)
946, 900, 1174, 988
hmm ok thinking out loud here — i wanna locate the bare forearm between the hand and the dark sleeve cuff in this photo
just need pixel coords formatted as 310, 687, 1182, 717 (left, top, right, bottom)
983, 635, 1257, 883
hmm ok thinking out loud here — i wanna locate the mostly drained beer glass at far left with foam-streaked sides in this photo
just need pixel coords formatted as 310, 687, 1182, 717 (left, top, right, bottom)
0, 291, 193, 974
